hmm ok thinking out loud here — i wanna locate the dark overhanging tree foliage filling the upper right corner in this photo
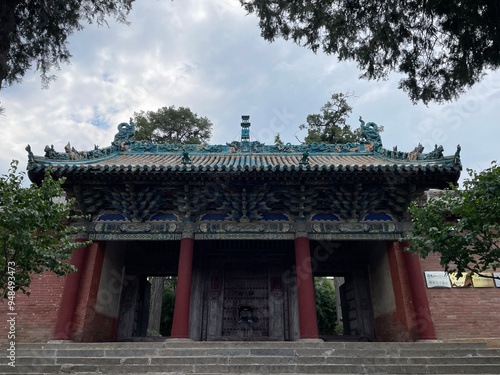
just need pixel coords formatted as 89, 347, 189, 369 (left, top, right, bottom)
240, 0, 500, 103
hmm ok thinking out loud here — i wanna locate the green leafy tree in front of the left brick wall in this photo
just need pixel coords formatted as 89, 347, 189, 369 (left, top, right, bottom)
0, 161, 87, 298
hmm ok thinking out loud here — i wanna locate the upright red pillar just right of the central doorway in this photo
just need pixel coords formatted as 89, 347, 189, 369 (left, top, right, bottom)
295, 237, 319, 339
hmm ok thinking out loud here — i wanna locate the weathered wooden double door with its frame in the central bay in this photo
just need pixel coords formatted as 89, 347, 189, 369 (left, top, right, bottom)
202, 256, 290, 341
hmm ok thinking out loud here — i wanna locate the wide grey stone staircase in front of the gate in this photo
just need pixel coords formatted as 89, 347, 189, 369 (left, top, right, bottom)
0, 341, 500, 375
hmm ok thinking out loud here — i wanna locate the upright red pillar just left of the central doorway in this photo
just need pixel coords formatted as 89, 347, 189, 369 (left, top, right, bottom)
170, 238, 194, 339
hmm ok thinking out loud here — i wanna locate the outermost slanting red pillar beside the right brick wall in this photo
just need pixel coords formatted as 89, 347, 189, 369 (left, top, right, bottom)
399, 243, 436, 340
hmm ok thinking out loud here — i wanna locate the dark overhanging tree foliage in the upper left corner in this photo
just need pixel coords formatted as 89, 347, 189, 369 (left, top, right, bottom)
0, 0, 133, 88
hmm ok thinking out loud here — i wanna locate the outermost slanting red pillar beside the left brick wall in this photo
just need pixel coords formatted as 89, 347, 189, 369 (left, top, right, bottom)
53, 245, 90, 340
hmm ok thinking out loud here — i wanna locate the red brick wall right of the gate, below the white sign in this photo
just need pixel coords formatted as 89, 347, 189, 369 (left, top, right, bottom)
420, 255, 500, 339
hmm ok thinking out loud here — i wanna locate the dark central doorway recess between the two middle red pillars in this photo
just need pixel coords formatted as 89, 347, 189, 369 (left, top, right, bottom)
197, 241, 296, 341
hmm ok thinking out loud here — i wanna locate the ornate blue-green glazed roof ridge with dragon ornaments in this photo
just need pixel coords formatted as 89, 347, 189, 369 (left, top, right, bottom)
26, 118, 461, 169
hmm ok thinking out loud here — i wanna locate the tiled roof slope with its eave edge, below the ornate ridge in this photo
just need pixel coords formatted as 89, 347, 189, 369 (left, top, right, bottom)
28, 152, 461, 188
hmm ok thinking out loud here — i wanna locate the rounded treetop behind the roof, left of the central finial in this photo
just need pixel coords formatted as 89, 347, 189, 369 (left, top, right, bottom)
134, 106, 212, 143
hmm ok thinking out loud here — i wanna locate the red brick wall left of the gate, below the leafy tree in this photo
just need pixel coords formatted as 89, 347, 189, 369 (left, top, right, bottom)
0, 272, 66, 343
